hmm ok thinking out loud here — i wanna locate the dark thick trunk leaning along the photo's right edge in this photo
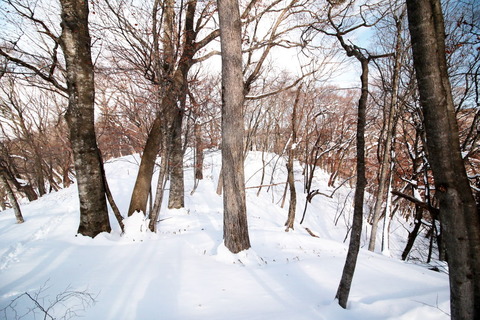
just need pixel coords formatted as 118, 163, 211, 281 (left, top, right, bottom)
407, 0, 480, 320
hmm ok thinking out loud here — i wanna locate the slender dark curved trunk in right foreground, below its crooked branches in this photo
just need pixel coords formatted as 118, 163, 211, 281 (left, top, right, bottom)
335, 59, 368, 308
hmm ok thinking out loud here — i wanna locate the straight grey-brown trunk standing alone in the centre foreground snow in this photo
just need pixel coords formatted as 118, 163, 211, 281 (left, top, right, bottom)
217, 0, 250, 253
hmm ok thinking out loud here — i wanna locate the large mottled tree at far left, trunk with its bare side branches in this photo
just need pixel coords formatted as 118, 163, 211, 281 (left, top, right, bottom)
0, 0, 110, 237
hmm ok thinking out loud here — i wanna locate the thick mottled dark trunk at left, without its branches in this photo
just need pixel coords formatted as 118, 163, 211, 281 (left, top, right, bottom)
60, 0, 110, 237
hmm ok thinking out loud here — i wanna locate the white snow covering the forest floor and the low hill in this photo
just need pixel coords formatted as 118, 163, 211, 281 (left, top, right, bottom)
0, 152, 449, 320
